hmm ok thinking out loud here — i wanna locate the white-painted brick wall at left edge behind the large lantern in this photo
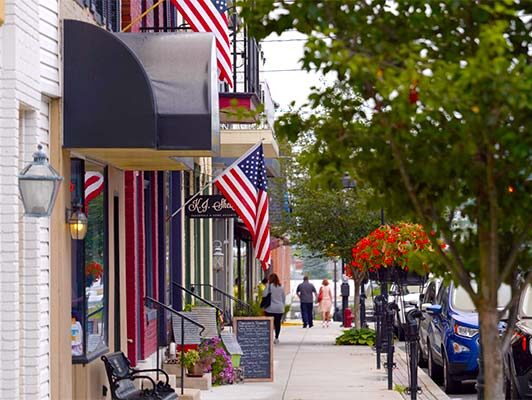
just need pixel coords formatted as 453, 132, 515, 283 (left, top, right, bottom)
0, 0, 60, 400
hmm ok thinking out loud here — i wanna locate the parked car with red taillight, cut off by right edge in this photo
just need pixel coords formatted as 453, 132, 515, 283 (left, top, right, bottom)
504, 285, 532, 399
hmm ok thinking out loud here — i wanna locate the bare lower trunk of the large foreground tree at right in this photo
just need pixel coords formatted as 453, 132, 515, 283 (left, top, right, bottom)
479, 306, 504, 400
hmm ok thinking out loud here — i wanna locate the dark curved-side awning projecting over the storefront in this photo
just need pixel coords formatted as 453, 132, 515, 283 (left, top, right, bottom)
64, 20, 220, 158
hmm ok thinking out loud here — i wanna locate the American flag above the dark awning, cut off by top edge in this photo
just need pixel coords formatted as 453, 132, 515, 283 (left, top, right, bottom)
172, 0, 233, 87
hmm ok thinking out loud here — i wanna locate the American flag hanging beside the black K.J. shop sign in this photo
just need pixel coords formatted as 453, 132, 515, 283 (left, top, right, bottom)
214, 143, 271, 270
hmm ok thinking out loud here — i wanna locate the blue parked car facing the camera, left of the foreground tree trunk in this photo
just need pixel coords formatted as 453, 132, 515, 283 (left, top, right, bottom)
426, 282, 511, 393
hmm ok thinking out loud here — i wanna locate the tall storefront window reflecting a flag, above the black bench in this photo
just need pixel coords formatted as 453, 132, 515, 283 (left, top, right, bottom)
71, 159, 108, 363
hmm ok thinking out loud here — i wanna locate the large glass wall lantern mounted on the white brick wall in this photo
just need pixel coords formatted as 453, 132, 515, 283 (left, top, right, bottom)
18, 144, 63, 217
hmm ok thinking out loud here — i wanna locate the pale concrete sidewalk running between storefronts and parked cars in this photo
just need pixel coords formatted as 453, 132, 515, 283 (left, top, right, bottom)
201, 321, 447, 400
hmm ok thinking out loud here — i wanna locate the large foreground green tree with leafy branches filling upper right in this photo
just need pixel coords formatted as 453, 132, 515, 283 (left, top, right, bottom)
241, 0, 532, 399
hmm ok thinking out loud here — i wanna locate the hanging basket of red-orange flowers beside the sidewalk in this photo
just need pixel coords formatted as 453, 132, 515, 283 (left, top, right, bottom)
351, 223, 432, 285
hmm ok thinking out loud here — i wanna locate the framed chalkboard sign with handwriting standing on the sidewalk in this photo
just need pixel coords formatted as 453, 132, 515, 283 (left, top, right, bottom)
234, 317, 273, 382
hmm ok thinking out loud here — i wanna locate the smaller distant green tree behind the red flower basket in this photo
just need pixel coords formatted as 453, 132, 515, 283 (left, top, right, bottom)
290, 161, 379, 328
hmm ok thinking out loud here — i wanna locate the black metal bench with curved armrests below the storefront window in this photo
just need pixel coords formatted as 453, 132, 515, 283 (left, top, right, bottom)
102, 351, 178, 400
